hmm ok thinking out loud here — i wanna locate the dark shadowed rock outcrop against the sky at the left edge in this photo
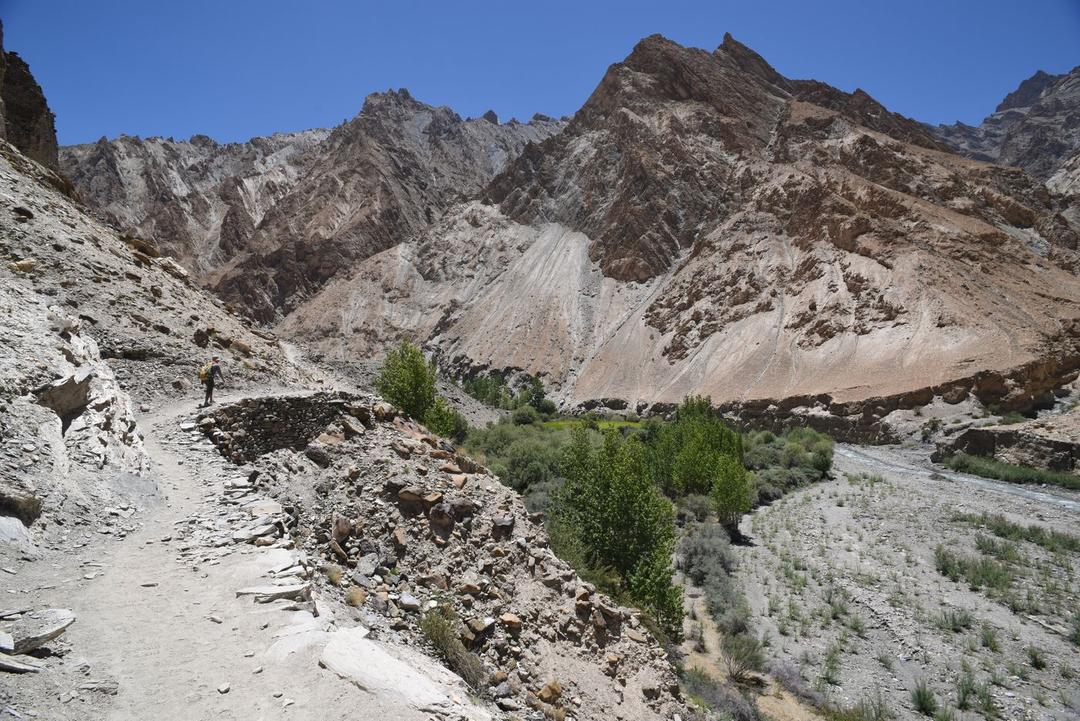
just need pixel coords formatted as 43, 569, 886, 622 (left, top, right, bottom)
0, 21, 59, 171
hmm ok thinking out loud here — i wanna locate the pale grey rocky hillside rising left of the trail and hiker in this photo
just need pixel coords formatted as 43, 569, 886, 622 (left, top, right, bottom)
0, 134, 298, 538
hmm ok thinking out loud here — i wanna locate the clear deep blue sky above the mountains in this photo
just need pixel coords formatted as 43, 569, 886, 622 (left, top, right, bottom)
0, 0, 1080, 144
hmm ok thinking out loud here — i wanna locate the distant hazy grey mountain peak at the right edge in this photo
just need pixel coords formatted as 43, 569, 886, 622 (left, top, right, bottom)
934, 67, 1080, 180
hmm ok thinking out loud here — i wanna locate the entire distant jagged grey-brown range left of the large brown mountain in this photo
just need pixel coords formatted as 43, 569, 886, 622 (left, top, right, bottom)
60, 91, 563, 322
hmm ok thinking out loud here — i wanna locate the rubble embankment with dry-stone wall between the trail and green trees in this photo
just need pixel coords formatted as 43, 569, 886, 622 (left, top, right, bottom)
197, 393, 683, 719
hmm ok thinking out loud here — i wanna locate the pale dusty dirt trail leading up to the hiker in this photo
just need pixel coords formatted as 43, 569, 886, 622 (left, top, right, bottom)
6, 393, 419, 721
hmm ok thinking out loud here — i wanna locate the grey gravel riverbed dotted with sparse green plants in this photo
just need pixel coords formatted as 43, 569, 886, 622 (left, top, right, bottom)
739, 446, 1080, 719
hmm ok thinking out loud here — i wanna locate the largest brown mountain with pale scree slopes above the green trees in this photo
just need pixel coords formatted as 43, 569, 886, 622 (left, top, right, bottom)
281, 37, 1080, 418
